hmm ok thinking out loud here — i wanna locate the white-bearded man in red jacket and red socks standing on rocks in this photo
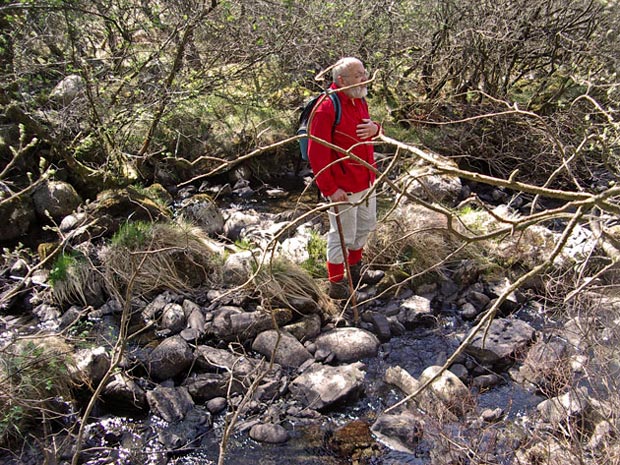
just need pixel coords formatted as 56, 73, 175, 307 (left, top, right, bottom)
308, 57, 383, 299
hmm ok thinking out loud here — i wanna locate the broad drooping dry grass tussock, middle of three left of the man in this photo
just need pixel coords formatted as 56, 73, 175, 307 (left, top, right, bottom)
100, 218, 222, 295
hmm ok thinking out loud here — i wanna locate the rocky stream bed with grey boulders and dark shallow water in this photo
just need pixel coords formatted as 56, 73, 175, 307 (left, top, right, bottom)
0, 160, 620, 465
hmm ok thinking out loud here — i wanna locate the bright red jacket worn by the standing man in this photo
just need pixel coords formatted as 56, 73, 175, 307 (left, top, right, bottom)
308, 84, 381, 197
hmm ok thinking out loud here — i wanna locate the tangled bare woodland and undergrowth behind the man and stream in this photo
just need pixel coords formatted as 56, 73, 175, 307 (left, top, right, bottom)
0, 0, 620, 462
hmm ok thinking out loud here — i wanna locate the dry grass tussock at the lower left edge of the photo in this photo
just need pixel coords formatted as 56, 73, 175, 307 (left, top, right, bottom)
0, 337, 72, 444
